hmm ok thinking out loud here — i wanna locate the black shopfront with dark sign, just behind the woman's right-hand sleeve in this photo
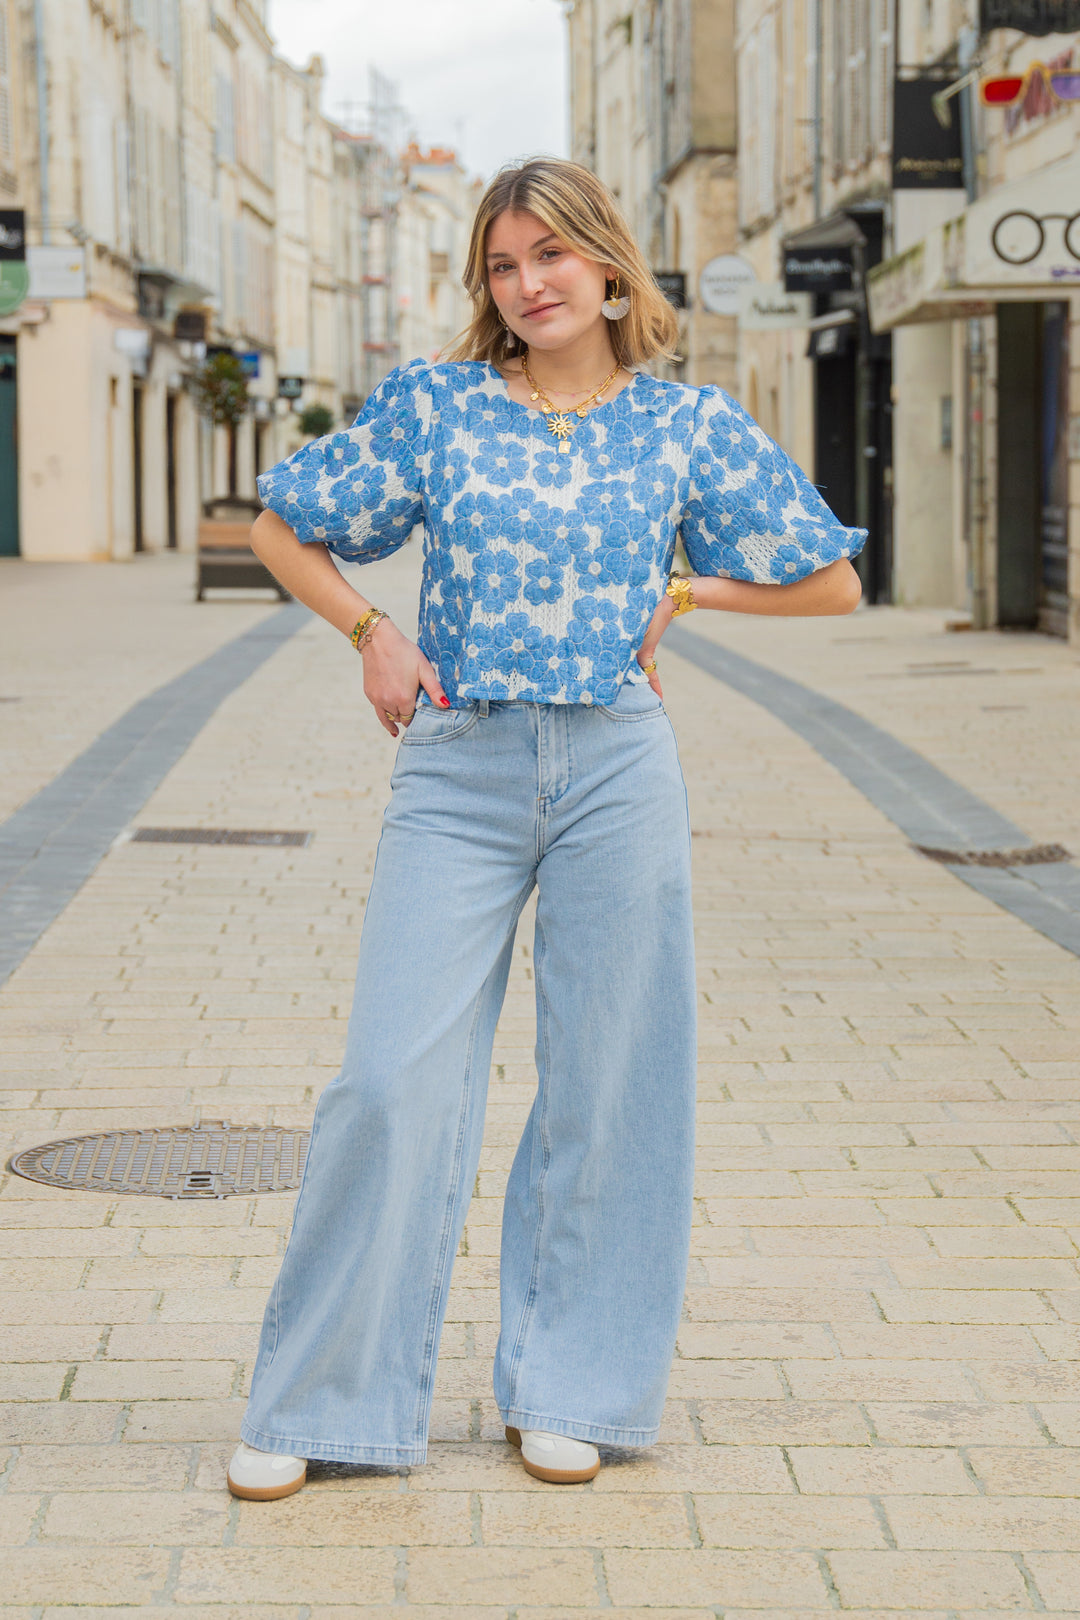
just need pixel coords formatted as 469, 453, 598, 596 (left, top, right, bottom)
782, 201, 892, 603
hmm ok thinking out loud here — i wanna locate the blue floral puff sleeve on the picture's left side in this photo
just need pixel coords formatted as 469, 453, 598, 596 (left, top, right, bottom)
257, 360, 431, 562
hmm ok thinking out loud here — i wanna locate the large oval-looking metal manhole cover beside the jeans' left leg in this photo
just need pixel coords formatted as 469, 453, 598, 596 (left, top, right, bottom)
8, 1121, 311, 1199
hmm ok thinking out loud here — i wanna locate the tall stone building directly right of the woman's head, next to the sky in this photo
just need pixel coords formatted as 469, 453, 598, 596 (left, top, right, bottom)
565, 0, 740, 389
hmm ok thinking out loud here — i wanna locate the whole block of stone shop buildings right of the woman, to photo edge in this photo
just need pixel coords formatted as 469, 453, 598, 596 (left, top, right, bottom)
737, 0, 1080, 637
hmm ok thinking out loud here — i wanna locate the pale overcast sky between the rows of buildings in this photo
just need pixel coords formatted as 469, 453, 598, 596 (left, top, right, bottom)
270, 0, 567, 178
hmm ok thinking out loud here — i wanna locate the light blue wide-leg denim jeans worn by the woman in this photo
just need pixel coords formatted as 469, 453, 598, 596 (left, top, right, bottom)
241, 684, 696, 1463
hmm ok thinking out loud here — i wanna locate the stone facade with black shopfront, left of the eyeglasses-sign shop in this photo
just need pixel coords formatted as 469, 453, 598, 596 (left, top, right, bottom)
735, 0, 895, 601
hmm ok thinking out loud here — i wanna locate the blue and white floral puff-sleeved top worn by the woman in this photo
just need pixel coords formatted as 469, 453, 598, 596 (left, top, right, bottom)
259, 360, 866, 703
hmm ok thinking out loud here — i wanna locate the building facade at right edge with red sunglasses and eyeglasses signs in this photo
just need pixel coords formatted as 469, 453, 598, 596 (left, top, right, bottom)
868, 0, 1080, 643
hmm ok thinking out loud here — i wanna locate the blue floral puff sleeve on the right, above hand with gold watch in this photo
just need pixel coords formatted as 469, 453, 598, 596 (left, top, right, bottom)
680, 386, 866, 585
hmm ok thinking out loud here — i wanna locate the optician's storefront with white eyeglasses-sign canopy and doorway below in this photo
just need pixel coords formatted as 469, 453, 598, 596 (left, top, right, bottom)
866, 152, 1080, 638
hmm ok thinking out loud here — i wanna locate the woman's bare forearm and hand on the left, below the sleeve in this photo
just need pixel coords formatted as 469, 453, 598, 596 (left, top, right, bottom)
251, 510, 450, 737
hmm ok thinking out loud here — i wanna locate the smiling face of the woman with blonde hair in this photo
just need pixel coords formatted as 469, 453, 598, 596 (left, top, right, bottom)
487, 211, 614, 348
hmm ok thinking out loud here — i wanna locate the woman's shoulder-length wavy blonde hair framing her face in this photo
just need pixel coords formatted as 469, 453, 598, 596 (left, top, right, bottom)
442, 157, 678, 366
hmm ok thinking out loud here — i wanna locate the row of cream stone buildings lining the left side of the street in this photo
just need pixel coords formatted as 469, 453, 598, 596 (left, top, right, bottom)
0, 0, 468, 559
